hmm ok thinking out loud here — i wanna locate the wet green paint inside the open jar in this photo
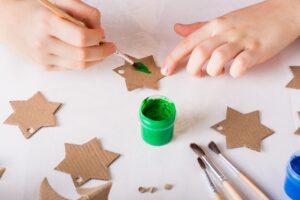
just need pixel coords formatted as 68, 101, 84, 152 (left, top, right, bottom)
142, 99, 175, 121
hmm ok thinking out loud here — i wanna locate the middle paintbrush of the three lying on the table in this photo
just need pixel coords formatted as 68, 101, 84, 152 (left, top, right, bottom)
190, 143, 242, 200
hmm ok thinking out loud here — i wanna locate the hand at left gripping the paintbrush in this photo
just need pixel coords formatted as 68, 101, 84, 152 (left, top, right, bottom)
0, 0, 116, 70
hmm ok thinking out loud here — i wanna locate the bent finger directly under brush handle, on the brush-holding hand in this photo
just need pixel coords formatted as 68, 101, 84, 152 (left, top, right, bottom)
49, 16, 103, 47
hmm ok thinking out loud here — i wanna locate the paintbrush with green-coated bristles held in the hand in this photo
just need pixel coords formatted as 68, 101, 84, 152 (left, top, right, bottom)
39, 0, 151, 74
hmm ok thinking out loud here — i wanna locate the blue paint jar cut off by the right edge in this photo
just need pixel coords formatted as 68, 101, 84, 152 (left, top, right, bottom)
284, 152, 300, 200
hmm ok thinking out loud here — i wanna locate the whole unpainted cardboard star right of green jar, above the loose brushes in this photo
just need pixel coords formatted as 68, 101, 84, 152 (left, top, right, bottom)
211, 107, 274, 151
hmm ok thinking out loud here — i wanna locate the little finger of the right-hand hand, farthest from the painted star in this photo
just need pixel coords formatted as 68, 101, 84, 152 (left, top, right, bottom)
229, 50, 258, 78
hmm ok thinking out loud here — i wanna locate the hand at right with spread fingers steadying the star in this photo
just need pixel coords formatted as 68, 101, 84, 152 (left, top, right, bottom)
162, 0, 300, 77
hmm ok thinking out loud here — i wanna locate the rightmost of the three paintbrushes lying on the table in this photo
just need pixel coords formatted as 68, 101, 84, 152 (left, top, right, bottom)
208, 141, 270, 200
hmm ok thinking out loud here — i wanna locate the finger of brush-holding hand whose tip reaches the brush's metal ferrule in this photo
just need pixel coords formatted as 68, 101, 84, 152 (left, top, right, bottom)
48, 37, 116, 62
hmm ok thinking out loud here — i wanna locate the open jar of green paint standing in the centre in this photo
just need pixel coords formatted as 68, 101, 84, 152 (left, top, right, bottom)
139, 96, 176, 146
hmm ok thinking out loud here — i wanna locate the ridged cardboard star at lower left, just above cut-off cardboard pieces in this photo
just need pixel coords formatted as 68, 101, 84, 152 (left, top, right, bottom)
55, 138, 120, 187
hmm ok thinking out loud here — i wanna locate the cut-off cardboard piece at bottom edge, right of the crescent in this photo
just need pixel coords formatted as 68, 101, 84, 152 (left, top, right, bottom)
76, 182, 112, 200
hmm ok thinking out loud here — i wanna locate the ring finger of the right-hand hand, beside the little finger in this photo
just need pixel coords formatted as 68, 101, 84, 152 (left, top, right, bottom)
206, 43, 243, 76
